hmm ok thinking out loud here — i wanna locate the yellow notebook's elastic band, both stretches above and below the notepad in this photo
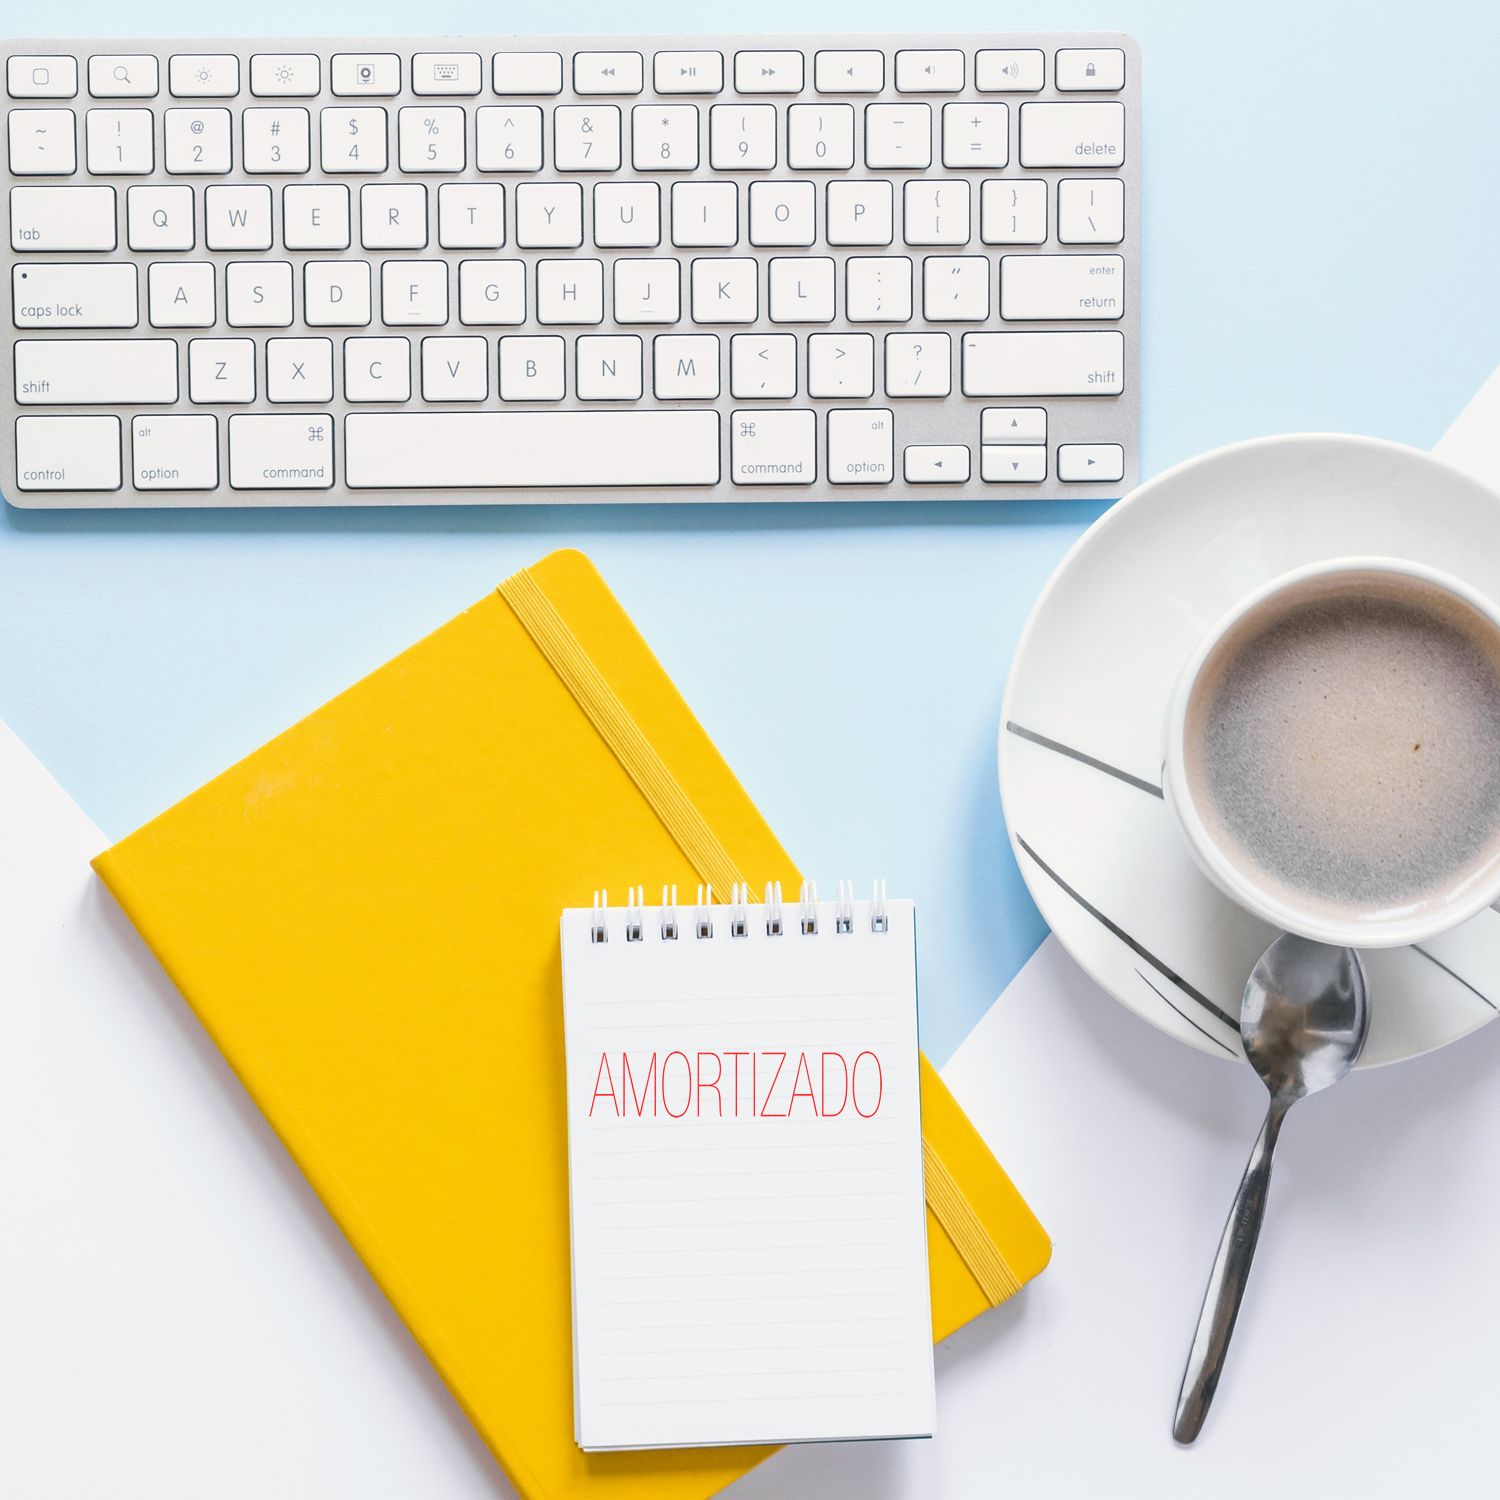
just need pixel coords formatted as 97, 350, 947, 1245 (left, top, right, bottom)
500, 570, 1020, 1307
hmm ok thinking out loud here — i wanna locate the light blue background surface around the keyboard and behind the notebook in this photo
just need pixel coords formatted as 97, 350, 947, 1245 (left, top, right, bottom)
0, 0, 1500, 1062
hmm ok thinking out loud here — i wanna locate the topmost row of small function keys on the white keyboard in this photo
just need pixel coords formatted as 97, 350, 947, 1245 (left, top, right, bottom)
6, 47, 1125, 99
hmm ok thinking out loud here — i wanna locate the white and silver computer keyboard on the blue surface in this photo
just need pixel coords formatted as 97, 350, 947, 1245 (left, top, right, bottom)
0, 35, 1140, 507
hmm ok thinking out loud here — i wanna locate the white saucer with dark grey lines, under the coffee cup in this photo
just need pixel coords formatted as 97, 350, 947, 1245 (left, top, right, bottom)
999, 434, 1500, 1067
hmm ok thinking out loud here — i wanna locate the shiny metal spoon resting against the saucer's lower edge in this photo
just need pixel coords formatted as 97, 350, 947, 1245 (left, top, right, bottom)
1172, 933, 1370, 1443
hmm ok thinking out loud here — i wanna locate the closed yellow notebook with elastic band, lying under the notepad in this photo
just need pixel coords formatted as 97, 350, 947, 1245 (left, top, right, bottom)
95, 552, 1049, 1500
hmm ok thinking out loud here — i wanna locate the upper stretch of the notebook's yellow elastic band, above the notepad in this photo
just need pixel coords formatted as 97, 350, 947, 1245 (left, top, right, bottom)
500, 569, 746, 900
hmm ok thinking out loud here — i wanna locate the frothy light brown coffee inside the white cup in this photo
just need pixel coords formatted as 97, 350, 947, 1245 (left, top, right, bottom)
1184, 572, 1500, 921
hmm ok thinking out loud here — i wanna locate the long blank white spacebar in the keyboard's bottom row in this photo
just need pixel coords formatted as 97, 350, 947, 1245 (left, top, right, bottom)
344, 411, 719, 489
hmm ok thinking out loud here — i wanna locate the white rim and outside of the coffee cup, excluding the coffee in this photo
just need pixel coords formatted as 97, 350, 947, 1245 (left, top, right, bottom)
1163, 557, 1500, 948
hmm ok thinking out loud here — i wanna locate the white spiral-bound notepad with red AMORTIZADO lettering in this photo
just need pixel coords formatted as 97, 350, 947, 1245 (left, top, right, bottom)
563, 893, 935, 1451
